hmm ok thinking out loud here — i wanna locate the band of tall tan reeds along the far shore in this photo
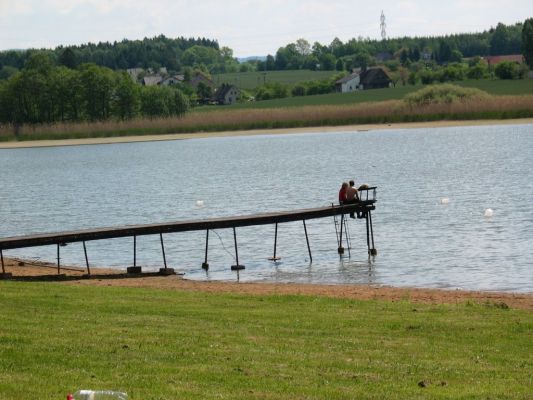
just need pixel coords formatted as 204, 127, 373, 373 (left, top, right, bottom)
0, 95, 533, 141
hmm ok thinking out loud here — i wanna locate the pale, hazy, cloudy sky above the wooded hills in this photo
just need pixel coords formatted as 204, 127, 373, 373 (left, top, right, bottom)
0, 0, 533, 57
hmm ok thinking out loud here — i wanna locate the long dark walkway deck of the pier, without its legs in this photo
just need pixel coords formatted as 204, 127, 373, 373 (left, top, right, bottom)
0, 200, 376, 250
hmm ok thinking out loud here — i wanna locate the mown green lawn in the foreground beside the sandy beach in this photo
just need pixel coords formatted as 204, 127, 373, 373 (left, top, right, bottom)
0, 282, 533, 400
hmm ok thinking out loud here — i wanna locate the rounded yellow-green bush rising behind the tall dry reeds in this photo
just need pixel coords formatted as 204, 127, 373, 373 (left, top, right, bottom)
404, 84, 489, 106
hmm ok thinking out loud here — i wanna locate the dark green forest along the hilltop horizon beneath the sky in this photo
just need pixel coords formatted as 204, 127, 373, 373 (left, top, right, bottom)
0, 23, 523, 79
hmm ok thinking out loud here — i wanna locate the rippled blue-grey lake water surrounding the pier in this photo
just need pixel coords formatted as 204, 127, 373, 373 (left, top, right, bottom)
0, 125, 533, 292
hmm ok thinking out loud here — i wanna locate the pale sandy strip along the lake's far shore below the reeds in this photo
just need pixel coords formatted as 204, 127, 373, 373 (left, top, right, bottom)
0, 118, 533, 149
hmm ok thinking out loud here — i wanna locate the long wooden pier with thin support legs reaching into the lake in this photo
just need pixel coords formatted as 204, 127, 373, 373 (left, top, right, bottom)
0, 187, 376, 276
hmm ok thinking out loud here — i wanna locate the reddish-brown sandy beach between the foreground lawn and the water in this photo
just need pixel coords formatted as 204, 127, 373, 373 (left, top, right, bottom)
4, 259, 533, 310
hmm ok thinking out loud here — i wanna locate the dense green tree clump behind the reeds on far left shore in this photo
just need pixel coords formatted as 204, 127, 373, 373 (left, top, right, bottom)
0, 53, 189, 126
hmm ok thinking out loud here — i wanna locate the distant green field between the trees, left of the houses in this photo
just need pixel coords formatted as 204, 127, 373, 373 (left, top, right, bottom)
212, 70, 338, 90
